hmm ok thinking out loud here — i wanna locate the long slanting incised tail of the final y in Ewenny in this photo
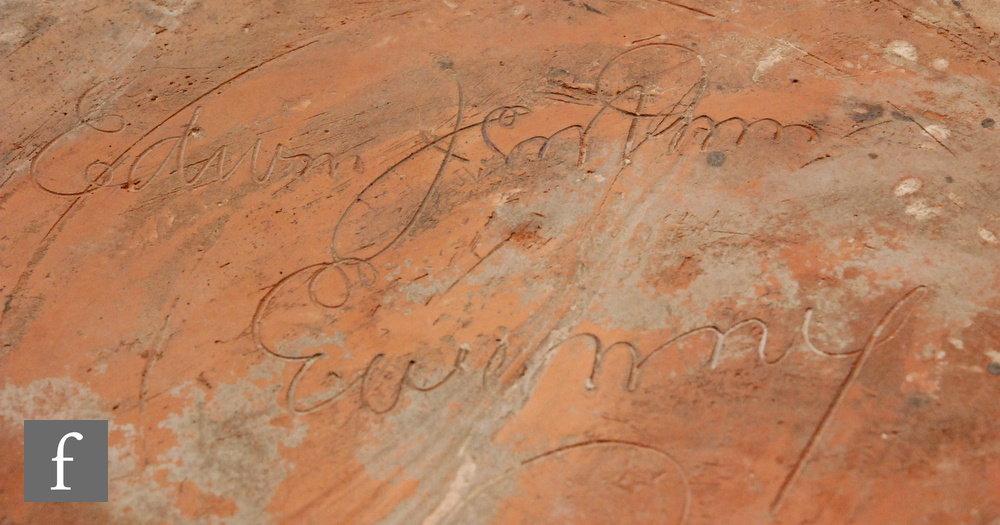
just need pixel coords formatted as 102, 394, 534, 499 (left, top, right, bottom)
771, 285, 927, 515
